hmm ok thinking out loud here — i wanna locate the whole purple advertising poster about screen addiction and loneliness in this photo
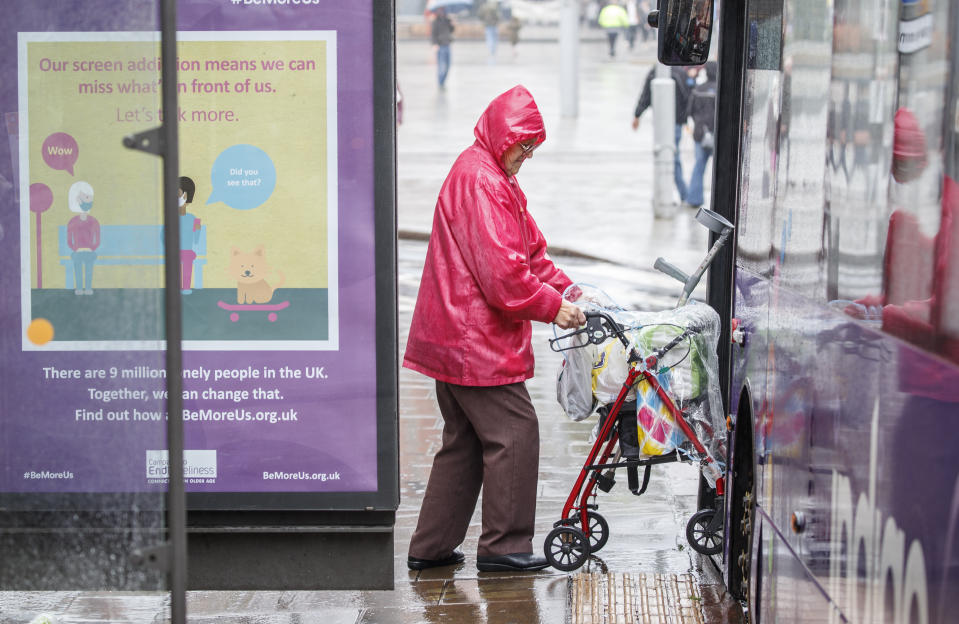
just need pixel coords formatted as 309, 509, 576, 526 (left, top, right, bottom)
0, 0, 388, 504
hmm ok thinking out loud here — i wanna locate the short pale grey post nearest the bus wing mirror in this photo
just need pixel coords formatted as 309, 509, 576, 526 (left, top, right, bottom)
652, 63, 676, 219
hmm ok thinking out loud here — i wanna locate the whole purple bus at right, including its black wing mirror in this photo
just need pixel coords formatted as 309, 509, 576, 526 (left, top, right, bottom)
659, 0, 959, 624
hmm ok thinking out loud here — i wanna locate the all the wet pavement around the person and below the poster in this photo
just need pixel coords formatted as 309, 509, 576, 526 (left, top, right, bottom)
0, 26, 743, 624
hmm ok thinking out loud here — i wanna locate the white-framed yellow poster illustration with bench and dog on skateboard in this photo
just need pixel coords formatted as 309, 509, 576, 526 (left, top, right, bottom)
20, 31, 337, 350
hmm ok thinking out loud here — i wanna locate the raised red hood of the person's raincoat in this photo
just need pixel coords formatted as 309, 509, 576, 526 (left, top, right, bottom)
473, 85, 546, 167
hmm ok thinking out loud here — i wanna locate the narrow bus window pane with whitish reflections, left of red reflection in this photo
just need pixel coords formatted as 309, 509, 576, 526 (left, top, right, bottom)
823, 0, 898, 301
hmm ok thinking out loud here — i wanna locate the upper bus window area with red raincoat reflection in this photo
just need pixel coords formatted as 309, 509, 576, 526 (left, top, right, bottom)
827, 3, 959, 361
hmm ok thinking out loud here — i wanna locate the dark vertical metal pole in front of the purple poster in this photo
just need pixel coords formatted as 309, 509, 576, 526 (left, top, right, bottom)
160, 0, 187, 624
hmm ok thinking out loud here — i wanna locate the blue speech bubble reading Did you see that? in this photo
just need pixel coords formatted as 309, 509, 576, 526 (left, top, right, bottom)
206, 144, 276, 210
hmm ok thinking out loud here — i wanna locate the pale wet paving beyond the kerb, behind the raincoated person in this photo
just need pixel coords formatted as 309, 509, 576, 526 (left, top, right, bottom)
397, 25, 711, 292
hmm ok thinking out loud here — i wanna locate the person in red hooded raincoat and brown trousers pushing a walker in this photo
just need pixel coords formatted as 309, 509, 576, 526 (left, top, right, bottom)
403, 86, 586, 571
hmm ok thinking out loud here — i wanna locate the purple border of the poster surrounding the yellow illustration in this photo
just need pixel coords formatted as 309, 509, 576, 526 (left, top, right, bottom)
0, 0, 396, 506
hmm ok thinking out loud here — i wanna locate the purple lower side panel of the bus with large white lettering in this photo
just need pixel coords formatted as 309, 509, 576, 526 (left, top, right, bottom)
748, 143, 959, 623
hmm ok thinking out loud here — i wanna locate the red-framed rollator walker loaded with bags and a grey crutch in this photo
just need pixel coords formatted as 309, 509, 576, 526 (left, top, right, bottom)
544, 208, 734, 572
